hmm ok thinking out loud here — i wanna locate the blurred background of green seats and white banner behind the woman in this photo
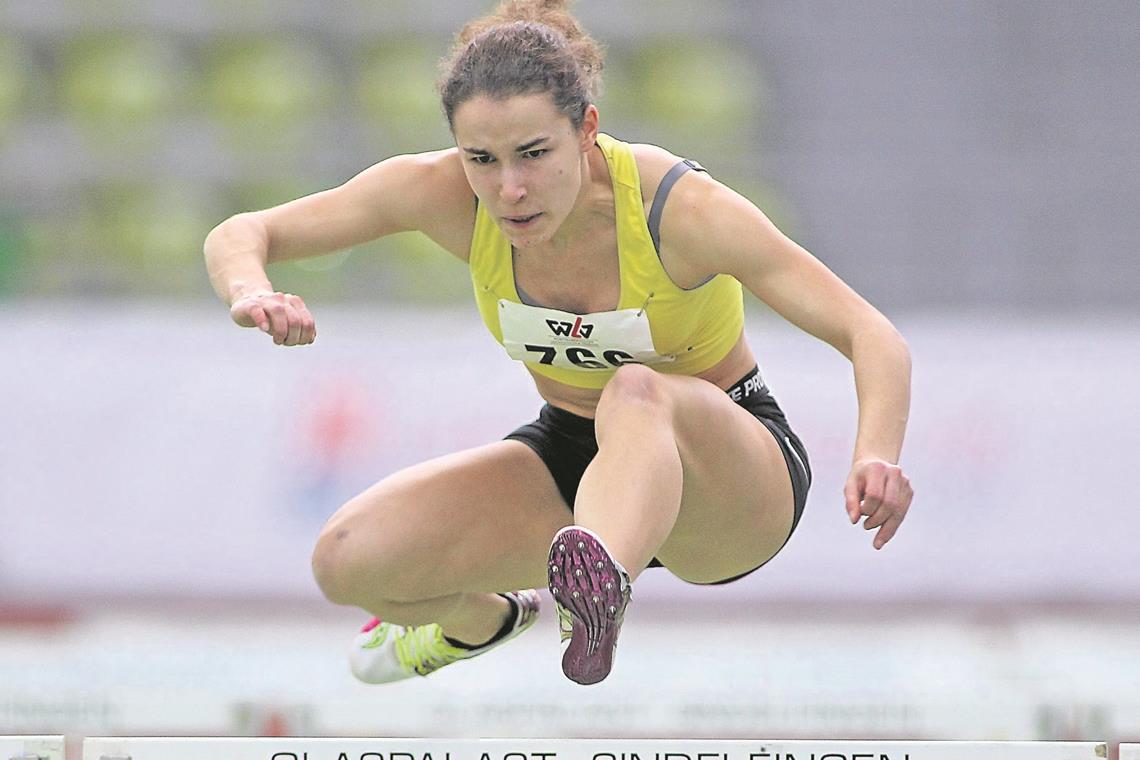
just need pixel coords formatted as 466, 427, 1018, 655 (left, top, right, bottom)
0, 0, 1140, 756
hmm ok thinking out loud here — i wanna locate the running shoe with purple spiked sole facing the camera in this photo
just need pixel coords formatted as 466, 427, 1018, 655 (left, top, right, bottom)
547, 525, 630, 684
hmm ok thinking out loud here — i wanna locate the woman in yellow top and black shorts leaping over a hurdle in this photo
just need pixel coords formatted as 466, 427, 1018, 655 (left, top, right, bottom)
204, 0, 913, 684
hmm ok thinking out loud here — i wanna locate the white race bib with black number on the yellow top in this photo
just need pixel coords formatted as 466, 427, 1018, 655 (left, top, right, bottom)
499, 300, 674, 370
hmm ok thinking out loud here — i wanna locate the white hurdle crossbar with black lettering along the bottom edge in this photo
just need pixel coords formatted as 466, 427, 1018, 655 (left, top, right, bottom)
83, 737, 1103, 760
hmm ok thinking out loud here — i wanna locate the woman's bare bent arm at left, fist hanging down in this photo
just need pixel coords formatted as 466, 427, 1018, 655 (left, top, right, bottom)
203, 149, 473, 345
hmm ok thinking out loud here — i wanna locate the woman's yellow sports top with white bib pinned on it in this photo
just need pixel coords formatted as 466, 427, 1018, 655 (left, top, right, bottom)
469, 134, 744, 389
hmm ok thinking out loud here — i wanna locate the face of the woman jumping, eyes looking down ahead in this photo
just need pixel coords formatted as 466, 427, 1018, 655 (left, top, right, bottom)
453, 92, 597, 248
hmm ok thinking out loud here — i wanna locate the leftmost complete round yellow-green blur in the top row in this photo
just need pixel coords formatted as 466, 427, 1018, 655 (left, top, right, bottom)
59, 33, 193, 136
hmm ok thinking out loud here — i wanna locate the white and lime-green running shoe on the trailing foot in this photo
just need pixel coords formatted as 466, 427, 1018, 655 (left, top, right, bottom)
349, 589, 538, 684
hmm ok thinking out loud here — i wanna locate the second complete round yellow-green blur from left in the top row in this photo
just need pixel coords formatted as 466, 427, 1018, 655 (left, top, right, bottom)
204, 36, 342, 152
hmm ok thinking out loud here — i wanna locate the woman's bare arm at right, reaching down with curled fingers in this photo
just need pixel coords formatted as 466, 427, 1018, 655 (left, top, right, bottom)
661, 172, 913, 549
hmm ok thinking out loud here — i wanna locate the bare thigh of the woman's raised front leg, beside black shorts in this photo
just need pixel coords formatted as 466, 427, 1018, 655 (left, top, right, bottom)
657, 376, 795, 582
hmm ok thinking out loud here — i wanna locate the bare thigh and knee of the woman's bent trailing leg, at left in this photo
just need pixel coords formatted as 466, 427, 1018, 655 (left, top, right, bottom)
321, 441, 572, 600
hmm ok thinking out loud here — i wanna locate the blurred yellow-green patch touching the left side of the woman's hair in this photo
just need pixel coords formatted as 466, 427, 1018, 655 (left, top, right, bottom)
356, 36, 453, 153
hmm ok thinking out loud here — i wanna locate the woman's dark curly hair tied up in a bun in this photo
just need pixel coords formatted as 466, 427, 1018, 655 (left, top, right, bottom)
439, 0, 603, 130
